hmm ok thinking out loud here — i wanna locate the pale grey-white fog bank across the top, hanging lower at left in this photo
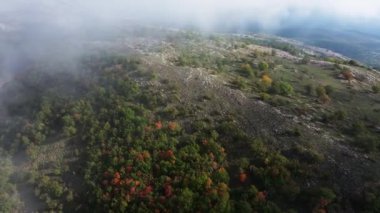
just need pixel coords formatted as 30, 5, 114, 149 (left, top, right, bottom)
0, 0, 380, 79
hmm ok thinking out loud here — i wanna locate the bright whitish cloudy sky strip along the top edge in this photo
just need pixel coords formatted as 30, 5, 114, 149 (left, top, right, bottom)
0, 0, 380, 28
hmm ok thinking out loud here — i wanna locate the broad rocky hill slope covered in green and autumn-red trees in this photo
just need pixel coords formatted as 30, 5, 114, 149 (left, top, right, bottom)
0, 28, 380, 212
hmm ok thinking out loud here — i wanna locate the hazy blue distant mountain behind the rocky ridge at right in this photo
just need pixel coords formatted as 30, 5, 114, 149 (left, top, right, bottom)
218, 15, 380, 68
